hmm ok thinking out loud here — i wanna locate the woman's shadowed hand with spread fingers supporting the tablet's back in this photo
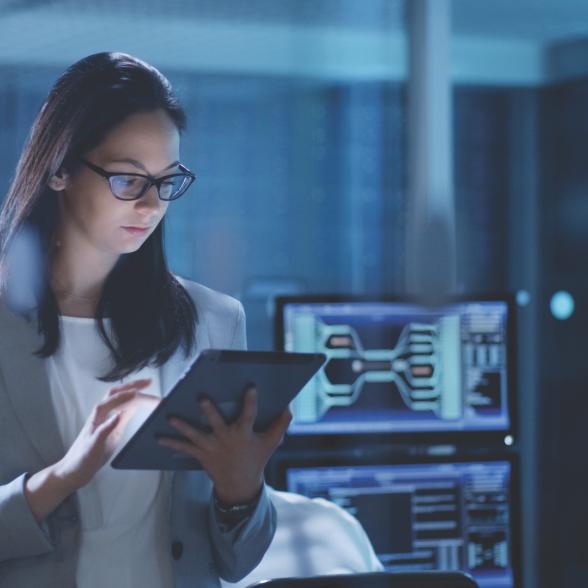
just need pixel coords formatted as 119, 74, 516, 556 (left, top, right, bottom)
158, 388, 292, 504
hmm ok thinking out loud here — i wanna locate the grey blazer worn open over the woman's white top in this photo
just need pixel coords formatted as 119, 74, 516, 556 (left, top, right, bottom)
0, 276, 276, 588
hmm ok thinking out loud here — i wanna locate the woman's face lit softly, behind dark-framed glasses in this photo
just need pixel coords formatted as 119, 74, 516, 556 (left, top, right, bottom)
60, 110, 180, 255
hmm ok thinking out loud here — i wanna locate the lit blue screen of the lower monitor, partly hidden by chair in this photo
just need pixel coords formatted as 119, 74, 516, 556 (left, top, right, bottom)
286, 460, 514, 588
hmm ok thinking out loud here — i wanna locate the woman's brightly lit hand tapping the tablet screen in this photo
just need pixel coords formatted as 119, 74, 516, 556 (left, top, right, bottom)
55, 379, 161, 492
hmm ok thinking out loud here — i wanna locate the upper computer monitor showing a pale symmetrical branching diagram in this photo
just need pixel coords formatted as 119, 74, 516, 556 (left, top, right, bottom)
276, 296, 514, 435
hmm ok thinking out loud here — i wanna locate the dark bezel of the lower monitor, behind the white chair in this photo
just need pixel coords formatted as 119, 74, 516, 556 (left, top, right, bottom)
273, 451, 522, 587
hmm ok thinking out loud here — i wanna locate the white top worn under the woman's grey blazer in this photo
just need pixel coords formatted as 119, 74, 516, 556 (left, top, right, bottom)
45, 316, 174, 588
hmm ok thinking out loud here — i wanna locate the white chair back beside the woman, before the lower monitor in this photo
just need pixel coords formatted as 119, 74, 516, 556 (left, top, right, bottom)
221, 489, 383, 588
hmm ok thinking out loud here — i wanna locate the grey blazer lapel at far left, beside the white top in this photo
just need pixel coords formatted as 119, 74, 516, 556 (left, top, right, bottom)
0, 305, 65, 465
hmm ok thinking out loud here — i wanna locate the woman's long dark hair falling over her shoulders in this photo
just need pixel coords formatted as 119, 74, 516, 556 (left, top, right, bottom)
0, 52, 197, 382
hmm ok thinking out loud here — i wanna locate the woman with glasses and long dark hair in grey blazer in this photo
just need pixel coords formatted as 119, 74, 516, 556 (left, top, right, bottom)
0, 53, 291, 588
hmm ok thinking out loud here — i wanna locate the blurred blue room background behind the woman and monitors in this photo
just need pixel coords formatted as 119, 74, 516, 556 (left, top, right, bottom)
0, 0, 588, 588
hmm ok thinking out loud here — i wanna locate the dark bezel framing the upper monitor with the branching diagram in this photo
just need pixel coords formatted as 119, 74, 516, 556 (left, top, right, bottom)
274, 293, 518, 448
